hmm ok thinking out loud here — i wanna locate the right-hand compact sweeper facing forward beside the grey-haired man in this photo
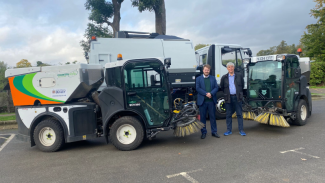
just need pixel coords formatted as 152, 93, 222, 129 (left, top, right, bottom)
243, 54, 312, 127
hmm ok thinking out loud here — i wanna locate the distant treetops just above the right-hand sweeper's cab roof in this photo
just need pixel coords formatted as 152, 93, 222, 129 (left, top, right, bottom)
256, 40, 302, 56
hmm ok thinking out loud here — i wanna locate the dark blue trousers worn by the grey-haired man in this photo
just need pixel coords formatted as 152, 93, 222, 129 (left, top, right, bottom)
226, 96, 244, 131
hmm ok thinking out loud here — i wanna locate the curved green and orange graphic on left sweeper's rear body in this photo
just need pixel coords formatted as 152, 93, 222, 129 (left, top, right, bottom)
8, 73, 65, 106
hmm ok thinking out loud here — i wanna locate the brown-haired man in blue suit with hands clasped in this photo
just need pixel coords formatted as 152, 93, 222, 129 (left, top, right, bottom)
196, 64, 220, 139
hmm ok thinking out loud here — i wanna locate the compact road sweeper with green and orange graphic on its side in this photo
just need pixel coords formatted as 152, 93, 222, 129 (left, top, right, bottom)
5, 58, 204, 152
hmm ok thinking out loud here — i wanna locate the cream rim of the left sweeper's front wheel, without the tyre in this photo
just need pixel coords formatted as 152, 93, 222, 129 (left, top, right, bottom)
116, 124, 137, 144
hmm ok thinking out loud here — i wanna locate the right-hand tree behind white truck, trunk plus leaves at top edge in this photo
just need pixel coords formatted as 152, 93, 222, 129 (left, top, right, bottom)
131, 0, 166, 35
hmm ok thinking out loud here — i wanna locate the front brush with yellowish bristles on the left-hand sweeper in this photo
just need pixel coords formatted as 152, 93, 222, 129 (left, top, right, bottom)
172, 103, 204, 137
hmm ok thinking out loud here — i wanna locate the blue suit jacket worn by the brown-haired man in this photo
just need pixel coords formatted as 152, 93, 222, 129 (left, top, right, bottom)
196, 74, 219, 105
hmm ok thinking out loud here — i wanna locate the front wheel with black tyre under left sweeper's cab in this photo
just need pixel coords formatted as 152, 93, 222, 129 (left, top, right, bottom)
109, 116, 144, 151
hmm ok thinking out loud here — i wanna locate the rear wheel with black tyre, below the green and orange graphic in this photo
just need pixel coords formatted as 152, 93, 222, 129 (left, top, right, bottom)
34, 119, 64, 152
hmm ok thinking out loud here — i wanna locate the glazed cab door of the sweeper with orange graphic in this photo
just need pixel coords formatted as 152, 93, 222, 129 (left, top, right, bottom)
123, 59, 171, 128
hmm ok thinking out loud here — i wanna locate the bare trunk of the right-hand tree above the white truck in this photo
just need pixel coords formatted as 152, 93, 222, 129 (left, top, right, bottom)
154, 0, 166, 35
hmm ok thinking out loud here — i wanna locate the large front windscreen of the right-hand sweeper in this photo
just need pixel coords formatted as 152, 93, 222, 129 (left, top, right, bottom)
248, 60, 282, 99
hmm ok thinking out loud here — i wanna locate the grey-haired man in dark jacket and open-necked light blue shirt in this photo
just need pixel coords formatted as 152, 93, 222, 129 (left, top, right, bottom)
220, 62, 246, 136
